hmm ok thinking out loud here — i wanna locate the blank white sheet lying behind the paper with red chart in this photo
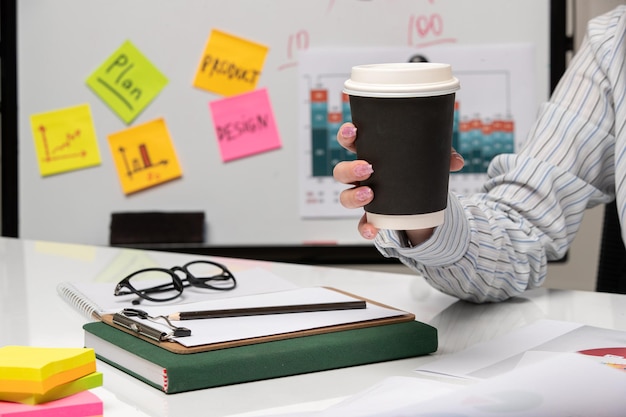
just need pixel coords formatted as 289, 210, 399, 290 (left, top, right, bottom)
416, 320, 626, 379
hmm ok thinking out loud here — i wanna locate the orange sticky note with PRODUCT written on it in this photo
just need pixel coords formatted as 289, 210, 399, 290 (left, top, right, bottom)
193, 29, 268, 97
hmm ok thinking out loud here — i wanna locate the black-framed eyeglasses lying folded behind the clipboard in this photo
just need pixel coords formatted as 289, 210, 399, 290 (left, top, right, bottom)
114, 260, 237, 305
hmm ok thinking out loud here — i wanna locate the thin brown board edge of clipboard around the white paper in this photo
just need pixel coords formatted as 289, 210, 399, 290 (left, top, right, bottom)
101, 287, 415, 354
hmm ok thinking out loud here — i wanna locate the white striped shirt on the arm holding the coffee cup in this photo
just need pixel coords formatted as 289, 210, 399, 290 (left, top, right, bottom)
375, 6, 626, 302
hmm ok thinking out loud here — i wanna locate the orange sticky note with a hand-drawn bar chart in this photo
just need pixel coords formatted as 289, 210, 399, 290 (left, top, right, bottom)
108, 118, 182, 194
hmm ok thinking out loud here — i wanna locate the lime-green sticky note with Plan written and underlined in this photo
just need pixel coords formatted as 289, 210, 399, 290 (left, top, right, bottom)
87, 41, 167, 124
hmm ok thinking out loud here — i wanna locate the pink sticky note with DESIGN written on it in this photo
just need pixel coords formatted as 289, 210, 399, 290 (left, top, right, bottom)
209, 89, 281, 162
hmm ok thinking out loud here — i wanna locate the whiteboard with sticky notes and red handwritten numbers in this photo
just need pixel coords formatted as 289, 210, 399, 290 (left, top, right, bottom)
17, 0, 550, 246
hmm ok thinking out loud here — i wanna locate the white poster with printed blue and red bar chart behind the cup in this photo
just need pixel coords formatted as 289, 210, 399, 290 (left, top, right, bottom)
298, 43, 538, 218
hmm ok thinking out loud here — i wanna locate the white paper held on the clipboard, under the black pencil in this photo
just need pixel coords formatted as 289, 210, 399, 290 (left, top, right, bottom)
129, 287, 405, 347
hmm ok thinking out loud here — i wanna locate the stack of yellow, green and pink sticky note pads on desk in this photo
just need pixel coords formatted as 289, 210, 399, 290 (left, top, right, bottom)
0, 346, 103, 417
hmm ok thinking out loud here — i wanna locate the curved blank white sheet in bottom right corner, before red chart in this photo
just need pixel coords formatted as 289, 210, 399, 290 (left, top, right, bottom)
394, 353, 626, 417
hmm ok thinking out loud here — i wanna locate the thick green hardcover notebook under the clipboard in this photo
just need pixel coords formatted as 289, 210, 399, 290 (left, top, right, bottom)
83, 321, 437, 394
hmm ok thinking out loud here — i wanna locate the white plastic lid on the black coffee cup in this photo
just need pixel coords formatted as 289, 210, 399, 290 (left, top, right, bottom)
343, 62, 460, 97
